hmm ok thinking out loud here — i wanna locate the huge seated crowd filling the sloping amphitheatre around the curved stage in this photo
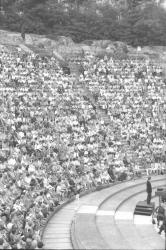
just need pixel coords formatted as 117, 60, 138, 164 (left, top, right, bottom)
0, 46, 166, 249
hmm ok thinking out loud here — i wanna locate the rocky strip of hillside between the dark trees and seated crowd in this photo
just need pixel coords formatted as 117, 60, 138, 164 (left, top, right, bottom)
0, 30, 166, 67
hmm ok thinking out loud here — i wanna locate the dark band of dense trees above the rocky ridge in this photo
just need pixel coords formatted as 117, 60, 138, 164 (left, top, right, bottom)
0, 0, 166, 46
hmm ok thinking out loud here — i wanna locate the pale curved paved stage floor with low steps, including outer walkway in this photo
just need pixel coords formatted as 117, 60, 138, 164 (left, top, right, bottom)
43, 176, 165, 250
